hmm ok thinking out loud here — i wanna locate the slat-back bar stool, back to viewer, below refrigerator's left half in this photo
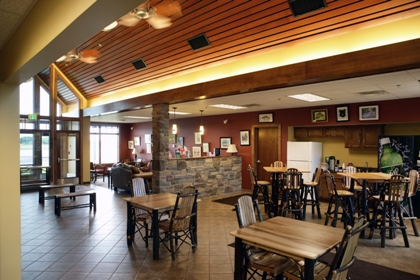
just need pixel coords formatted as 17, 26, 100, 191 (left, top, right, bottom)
281, 168, 303, 220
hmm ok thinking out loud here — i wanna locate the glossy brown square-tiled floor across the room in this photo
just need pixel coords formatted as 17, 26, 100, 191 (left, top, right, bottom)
21, 180, 420, 280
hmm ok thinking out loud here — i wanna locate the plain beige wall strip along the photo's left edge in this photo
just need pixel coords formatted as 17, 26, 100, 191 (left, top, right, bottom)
0, 83, 21, 280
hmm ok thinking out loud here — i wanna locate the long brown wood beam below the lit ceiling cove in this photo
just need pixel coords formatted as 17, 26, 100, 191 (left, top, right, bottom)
83, 39, 420, 117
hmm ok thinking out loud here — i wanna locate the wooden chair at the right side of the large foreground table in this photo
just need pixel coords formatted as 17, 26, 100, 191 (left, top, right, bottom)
284, 217, 369, 280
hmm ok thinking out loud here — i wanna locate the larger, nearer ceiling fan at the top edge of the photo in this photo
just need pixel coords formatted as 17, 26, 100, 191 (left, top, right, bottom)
102, 0, 182, 31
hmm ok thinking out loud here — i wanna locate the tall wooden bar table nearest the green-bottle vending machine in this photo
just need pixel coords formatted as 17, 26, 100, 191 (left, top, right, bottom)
337, 172, 392, 237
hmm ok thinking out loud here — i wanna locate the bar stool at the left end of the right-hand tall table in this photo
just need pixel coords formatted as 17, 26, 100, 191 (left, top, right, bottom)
322, 171, 354, 228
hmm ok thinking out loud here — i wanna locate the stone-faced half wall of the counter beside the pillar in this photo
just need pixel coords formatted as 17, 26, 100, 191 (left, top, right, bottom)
159, 156, 242, 197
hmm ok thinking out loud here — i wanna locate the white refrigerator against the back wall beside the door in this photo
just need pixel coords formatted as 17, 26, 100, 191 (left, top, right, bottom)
287, 141, 322, 181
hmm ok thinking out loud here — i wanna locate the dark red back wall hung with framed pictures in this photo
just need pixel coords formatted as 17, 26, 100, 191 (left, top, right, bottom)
120, 98, 420, 189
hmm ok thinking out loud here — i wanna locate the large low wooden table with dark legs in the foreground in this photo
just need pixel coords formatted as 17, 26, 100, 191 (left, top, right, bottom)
230, 217, 344, 280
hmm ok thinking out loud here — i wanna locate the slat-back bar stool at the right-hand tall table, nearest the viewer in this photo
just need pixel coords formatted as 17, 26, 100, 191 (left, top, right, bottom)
369, 175, 410, 248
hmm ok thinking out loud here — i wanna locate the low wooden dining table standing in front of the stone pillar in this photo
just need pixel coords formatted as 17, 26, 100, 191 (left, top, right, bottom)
124, 193, 177, 260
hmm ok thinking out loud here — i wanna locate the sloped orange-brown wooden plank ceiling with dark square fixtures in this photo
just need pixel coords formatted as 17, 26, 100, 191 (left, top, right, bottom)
39, 0, 420, 104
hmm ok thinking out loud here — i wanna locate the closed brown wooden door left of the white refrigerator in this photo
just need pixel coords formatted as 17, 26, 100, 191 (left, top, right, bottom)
252, 124, 281, 181
